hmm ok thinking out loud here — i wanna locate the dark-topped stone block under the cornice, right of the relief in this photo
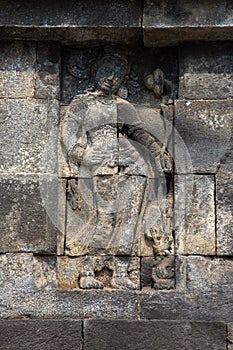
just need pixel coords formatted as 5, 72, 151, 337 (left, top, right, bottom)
179, 42, 233, 100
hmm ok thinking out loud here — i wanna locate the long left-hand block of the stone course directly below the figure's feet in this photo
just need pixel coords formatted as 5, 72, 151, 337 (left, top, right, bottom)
0, 286, 139, 319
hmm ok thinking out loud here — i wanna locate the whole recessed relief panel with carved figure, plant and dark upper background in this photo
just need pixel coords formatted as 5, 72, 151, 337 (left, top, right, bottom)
58, 46, 177, 290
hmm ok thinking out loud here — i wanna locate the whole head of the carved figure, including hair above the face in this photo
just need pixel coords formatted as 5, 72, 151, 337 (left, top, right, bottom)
96, 49, 129, 94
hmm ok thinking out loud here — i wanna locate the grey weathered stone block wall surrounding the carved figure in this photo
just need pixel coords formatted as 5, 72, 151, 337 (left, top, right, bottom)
0, 0, 233, 350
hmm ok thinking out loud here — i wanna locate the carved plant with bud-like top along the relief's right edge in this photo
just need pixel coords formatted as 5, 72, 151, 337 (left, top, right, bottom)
144, 68, 175, 290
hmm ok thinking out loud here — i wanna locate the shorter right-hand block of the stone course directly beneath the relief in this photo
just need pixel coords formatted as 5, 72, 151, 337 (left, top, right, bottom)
141, 291, 233, 322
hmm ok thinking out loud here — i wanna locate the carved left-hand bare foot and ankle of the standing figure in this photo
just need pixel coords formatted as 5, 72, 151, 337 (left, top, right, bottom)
79, 256, 103, 289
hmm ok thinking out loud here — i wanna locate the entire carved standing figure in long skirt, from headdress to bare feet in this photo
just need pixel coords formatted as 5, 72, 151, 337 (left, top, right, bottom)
62, 47, 170, 289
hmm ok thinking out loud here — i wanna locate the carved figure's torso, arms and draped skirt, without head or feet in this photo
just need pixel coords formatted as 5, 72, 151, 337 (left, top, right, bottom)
62, 93, 164, 256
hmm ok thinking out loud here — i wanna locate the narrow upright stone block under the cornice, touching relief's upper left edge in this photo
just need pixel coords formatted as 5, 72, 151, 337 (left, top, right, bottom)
35, 42, 61, 99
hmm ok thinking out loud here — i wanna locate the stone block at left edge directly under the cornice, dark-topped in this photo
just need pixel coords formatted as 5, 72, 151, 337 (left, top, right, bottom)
0, 42, 36, 98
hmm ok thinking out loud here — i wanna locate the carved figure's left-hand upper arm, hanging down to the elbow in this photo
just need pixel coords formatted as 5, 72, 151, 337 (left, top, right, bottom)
61, 98, 87, 164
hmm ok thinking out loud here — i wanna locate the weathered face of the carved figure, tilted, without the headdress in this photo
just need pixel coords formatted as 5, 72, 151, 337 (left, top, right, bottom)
96, 56, 128, 94
